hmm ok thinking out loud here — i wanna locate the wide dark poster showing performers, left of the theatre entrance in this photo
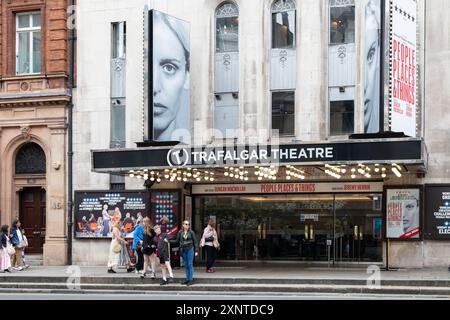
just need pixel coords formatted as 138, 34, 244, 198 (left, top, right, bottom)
75, 191, 149, 238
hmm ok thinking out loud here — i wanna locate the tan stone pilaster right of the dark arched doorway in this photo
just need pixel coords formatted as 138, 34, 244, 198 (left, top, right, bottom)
44, 123, 67, 265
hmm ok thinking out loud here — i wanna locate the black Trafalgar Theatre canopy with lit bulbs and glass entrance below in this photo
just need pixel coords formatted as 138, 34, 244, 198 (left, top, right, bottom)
92, 139, 426, 264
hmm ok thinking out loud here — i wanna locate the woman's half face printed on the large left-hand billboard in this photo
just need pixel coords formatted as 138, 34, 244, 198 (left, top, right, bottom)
153, 16, 189, 132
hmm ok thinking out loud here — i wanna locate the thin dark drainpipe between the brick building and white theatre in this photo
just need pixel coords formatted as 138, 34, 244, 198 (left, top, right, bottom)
67, 0, 75, 265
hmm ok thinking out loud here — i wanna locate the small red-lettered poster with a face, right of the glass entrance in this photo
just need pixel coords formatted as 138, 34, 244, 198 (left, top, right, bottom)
386, 188, 421, 239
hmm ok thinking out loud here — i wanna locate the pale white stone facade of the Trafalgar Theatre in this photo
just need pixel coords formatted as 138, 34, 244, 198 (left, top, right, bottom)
74, 0, 450, 267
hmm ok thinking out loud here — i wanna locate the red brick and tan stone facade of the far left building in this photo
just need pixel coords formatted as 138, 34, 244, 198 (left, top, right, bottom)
0, 0, 69, 265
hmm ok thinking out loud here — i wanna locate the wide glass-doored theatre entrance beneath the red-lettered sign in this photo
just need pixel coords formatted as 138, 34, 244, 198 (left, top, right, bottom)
194, 194, 382, 262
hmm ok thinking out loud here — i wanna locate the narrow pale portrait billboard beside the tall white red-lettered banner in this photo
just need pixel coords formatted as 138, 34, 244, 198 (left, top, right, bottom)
364, 0, 382, 133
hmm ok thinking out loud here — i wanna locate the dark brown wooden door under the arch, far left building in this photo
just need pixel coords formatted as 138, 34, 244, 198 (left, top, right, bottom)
19, 187, 46, 254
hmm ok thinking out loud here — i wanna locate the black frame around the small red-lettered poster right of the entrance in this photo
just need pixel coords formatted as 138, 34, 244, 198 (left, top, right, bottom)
382, 185, 424, 242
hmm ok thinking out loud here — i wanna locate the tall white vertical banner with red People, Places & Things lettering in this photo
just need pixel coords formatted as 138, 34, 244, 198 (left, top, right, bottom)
389, 0, 417, 137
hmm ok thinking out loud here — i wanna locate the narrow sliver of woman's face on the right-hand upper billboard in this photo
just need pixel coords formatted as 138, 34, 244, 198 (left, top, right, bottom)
364, 8, 380, 128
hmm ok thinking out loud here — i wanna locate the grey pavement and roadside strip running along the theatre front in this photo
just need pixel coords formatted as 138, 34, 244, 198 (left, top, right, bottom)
0, 264, 450, 299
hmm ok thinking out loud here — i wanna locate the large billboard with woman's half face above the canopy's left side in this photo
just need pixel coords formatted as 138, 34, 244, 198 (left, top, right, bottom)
147, 10, 190, 142
